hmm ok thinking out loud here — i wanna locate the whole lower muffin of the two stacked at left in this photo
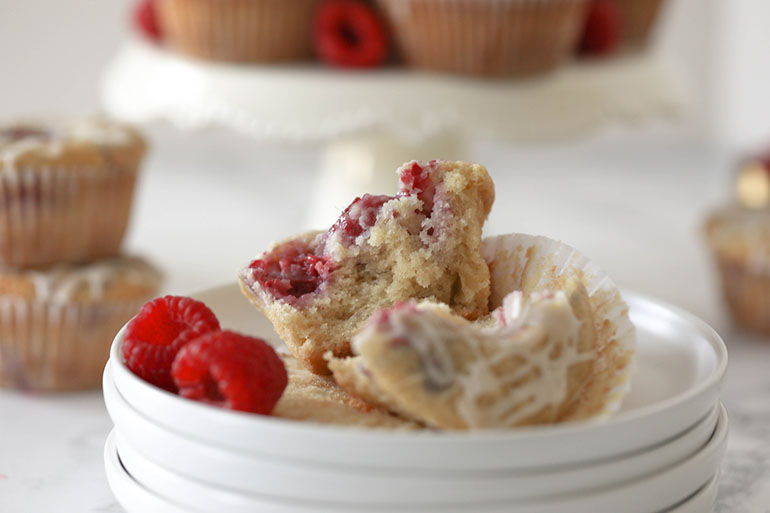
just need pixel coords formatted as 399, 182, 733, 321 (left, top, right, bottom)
0, 257, 160, 390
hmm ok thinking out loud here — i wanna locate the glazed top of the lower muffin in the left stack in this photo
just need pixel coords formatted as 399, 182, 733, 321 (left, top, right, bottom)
0, 257, 161, 304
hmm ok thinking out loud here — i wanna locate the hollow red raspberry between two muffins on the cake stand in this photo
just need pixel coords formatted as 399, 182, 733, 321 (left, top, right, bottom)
313, 0, 388, 68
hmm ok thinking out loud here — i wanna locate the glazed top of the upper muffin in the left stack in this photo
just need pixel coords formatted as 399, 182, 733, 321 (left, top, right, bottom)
0, 118, 146, 173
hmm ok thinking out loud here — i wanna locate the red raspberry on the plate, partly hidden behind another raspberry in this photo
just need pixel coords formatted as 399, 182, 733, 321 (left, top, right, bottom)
122, 296, 219, 392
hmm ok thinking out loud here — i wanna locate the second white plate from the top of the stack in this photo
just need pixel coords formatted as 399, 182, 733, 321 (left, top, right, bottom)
103, 368, 718, 504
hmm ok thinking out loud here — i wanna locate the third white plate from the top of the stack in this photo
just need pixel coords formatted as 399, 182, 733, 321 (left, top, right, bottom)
103, 407, 728, 513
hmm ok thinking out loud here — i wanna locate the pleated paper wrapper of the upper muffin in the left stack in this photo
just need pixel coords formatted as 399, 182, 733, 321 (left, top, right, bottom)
0, 164, 138, 267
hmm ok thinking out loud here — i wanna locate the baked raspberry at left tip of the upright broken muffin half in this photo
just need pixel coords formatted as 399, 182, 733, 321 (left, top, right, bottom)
249, 243, 332, 303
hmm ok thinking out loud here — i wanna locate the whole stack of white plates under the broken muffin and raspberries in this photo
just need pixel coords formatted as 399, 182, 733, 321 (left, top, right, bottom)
104, 285, 727, 513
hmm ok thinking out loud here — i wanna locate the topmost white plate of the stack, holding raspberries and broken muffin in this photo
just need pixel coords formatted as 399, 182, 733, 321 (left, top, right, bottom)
105, 284, 727, 472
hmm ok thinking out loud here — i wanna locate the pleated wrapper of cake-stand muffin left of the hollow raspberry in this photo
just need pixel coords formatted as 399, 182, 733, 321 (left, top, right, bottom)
157, 0, 319, 62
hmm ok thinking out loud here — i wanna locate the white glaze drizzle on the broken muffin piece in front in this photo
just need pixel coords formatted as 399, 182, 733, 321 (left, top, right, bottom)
362, 291, 596, 428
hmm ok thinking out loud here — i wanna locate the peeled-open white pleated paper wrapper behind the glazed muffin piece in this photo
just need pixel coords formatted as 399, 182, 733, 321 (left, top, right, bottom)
482, 234, 636, 420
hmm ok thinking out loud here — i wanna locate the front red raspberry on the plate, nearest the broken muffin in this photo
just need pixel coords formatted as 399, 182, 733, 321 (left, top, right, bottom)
171, 331, 288, 415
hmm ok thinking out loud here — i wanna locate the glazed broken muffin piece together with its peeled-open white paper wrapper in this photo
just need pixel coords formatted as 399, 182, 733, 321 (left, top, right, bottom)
327, 235, 635, 429
